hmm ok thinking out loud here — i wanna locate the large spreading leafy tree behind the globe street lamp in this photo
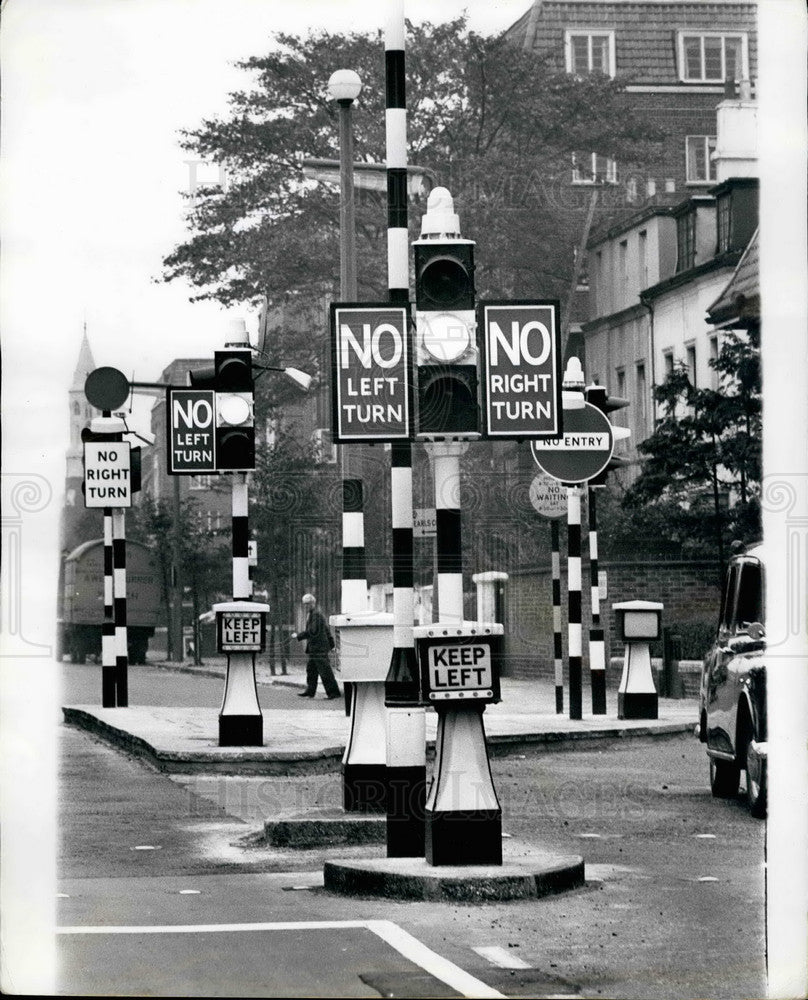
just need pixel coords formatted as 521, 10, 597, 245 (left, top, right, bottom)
164, 18, 662, 370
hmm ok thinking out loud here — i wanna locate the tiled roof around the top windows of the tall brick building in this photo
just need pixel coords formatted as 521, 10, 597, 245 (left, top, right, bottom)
506, 0, 757, 84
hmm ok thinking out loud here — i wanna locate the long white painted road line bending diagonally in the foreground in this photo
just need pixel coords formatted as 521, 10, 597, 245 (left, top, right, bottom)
56, 920, 505, 1000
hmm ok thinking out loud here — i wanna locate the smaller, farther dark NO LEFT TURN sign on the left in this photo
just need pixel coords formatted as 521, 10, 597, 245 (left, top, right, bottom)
166, 389, 216, 475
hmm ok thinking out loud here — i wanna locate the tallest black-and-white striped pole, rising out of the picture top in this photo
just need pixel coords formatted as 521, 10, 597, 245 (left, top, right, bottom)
384, 0, 426, 858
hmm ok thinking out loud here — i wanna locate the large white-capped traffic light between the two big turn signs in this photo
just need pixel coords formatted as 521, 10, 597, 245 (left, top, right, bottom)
413, 188, 480, 437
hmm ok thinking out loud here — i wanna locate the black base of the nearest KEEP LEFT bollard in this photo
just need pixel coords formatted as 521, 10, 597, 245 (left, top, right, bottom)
425, 809, 502, 865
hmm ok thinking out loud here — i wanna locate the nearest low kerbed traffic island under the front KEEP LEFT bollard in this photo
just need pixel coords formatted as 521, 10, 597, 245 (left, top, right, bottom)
323, 845, 585, 903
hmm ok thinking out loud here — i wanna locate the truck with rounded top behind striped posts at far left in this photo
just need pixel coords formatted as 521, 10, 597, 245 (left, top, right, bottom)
59, 538, 162, 663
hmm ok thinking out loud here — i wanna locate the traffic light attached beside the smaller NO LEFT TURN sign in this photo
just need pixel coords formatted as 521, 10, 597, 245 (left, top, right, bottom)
188, 350, 255, 472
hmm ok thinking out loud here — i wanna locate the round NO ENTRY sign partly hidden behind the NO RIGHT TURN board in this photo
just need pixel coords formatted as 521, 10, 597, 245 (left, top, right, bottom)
530, 403, 614, 483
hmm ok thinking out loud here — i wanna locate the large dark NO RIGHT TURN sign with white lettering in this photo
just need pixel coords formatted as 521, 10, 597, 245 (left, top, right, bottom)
479, 300, 562, 439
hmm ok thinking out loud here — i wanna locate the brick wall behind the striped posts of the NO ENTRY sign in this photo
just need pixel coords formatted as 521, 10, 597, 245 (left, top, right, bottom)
504, 546, 721, 681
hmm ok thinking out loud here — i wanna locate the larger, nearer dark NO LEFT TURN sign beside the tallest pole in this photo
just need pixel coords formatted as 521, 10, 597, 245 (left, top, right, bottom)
331, 303, 412, 442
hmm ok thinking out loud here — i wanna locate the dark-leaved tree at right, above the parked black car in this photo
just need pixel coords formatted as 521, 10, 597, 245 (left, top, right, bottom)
624, 328, 761, 563
